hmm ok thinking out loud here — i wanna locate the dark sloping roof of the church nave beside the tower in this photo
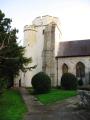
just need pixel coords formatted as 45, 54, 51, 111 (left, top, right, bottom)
56, 39, 90, 58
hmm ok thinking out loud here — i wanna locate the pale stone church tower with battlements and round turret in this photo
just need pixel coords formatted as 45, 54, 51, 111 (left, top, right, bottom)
21, 15, 60, 86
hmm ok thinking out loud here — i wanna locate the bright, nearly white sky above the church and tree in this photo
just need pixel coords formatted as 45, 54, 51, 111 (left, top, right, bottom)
0, 0, 90, 42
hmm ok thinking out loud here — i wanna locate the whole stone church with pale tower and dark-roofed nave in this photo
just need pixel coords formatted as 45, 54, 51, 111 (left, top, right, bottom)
15, 15, 90, 87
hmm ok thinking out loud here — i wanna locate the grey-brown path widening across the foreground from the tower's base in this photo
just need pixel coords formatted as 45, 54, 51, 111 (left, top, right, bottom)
20, 88, 90, 120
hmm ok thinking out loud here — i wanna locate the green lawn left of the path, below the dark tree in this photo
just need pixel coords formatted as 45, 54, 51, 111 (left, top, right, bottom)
0, 90, 27, 120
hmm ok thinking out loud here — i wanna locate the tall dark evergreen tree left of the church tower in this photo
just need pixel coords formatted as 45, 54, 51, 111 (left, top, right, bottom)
0, 10, 31, 90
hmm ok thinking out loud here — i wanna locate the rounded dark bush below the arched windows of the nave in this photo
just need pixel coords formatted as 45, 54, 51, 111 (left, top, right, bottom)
61, 73, 77, 90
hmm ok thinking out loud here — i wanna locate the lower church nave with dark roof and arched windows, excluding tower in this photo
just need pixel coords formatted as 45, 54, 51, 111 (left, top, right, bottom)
56, 39, 90, 85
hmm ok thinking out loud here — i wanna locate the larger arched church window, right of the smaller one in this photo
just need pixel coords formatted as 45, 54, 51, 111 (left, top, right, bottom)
76, 62, 85, 78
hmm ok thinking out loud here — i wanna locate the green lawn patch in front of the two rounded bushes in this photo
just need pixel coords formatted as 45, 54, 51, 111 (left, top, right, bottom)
35, 89, 77, 105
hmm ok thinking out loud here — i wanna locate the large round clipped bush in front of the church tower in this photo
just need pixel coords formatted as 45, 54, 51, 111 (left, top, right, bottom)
31, 72, 51, 93
